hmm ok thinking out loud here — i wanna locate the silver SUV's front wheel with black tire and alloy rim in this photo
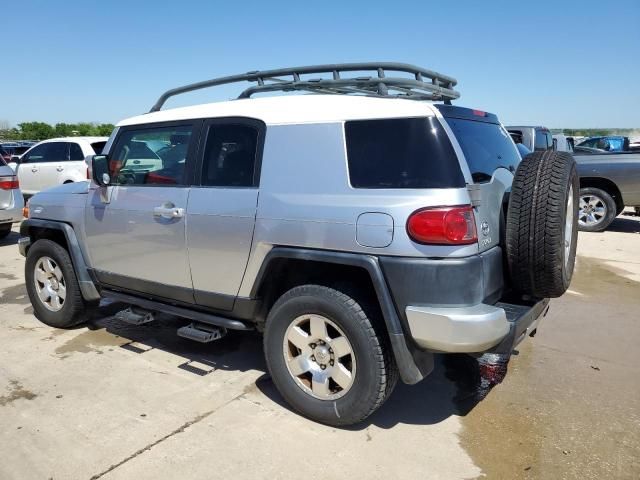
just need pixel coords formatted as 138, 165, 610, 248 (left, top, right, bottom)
25, 239, 86, 328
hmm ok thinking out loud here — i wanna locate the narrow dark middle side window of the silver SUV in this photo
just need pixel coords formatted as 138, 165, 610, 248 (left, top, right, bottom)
201, 124, 258, 187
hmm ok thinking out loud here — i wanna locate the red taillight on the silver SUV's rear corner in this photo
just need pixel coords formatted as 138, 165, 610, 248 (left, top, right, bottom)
407, 205, 478, 245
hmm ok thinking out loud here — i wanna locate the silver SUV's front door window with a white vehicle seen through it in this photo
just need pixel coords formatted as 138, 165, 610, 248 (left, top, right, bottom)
109, 125, 193, 185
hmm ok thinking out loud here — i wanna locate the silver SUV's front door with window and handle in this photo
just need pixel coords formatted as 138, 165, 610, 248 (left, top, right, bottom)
85, 120, 202, 303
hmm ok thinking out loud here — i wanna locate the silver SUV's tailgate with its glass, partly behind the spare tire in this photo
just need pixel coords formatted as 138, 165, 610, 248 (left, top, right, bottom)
440, 107, 520, 251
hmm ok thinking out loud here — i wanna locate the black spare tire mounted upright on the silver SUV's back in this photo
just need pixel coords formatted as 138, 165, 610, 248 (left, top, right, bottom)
506, 150, 579, 298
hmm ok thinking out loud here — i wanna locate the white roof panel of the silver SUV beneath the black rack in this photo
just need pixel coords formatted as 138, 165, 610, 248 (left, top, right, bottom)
117, 95, 434, 127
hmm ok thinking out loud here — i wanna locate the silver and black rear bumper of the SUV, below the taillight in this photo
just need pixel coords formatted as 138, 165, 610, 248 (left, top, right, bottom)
405, 299, 549, 353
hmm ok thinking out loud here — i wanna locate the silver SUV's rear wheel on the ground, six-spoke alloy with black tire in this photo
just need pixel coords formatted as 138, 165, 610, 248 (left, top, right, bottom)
264, 285, 397, 426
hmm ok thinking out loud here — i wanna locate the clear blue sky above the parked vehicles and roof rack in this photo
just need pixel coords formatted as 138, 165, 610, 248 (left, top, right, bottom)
0, 0, 640, 128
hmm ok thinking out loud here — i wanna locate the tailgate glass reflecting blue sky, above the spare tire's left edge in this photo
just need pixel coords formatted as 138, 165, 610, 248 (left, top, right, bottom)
447, 118, 520, 183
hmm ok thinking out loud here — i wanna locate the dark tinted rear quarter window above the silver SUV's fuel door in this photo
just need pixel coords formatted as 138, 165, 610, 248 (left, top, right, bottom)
345, 117, 465, 188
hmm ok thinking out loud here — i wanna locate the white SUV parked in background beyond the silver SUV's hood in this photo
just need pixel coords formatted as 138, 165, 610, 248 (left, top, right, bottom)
10, 137, 107, 195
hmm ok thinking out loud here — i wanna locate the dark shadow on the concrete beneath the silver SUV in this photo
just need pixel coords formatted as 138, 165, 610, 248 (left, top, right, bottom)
86, 303, 493, 430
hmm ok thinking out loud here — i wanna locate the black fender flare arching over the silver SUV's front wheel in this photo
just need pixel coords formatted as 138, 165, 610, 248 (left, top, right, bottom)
20, 218, 101, 301
